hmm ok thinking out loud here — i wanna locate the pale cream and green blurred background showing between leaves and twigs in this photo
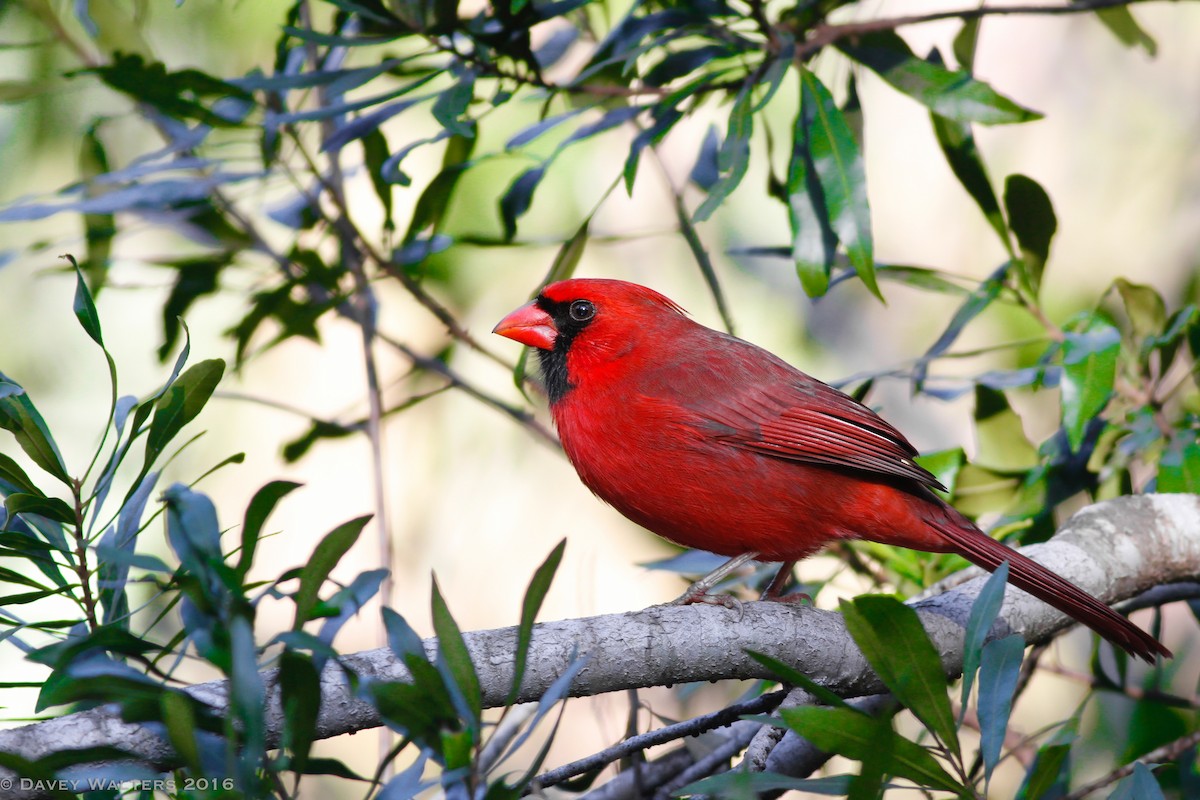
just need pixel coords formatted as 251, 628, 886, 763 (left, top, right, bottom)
0, 0, 1200, 786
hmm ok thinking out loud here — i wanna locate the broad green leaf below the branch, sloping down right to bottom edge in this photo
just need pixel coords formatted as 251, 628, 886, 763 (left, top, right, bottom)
779, 706, 970, 796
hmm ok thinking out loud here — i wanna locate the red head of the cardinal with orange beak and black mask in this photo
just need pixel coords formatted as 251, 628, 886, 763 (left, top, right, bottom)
492, 278, 686, 403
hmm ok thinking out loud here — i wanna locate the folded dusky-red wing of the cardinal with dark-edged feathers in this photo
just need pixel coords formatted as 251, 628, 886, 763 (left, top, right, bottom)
698, 367, 944, 491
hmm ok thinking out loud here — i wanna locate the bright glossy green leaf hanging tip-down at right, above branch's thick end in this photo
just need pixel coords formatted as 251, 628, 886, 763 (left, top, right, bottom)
1062, 318, 1121, 452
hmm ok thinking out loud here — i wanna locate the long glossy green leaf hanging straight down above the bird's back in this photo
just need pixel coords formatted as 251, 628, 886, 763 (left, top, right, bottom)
800, 67, 883, 300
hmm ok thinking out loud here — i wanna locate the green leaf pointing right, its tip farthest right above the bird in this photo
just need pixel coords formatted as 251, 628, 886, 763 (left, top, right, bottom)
838, 31, 1042, 125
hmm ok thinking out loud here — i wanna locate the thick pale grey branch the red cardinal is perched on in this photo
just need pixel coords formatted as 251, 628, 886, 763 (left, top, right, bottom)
0, 494, 1200, 796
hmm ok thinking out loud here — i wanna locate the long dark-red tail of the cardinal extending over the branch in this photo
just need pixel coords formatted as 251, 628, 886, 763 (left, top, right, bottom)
936, 523, 1171, 663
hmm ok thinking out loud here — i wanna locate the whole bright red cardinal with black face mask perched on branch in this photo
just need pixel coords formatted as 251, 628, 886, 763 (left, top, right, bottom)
493, 278, 1171, 662
